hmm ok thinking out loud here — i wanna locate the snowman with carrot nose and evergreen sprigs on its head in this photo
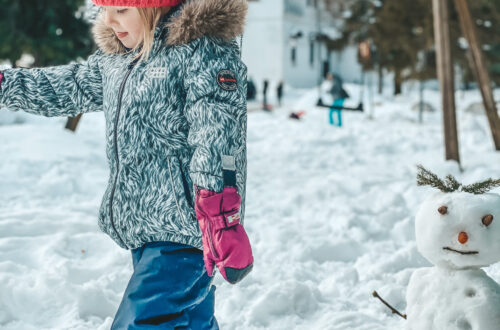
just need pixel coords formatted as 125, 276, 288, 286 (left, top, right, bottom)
405, 166, 500, 330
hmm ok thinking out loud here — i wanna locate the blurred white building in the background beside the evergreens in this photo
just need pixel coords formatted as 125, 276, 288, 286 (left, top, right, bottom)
243, 0, 361, 88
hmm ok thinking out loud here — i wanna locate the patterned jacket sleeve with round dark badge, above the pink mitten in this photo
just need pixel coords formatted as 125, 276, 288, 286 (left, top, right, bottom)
184, 37, 247, 194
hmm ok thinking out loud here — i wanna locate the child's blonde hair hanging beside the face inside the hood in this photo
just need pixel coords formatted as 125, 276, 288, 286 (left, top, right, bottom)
132, 7, 170, 61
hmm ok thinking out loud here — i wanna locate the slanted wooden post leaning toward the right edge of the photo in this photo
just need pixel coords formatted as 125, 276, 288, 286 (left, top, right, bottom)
454, 0, 500, 150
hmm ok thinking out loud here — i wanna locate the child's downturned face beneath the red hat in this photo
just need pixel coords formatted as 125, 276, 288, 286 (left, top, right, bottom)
104, 6, 144, 48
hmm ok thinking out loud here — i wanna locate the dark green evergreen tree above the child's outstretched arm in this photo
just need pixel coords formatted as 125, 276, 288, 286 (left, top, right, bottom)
0, 0, 93, 67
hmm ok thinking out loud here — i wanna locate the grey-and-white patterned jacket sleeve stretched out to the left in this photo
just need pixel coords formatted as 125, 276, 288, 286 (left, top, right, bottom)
0, 51, 103, 117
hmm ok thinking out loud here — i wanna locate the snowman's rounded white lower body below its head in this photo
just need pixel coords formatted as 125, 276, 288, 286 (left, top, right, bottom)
406, 267, 500, 330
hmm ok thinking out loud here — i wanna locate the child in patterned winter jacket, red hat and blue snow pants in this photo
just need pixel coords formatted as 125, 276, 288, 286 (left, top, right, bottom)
0, 0, 253, 329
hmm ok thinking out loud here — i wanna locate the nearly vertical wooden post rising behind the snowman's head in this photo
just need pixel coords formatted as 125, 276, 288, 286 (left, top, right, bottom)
432, 0, 460, 164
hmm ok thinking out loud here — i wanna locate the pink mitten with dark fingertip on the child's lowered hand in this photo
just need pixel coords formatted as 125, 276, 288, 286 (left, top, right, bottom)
195, 187, 253, 284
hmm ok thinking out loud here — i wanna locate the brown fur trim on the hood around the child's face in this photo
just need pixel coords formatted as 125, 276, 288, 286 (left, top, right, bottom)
92, 0, 248, 54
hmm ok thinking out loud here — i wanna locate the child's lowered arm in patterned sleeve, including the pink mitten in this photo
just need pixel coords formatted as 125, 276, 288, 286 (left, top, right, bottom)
185, 37, 253, 284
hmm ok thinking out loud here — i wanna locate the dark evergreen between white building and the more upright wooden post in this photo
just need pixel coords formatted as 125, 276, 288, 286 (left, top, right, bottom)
330, 0, 432, 94
